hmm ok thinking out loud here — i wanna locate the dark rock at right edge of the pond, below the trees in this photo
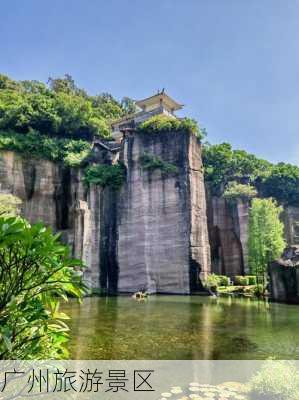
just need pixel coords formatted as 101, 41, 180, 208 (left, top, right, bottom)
269, 246, 299, 304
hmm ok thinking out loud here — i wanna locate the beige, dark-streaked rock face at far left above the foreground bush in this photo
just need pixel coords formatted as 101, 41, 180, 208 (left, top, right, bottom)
0, 151, 64, 229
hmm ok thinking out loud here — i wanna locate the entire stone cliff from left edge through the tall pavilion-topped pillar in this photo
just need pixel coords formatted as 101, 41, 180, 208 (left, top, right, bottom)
0, 132, 210, 294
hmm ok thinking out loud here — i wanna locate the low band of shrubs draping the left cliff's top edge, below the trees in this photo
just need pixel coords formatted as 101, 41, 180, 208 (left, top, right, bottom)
0, 130, 91, 167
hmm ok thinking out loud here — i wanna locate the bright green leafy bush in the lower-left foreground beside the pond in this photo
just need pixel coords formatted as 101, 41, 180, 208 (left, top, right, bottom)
0, 217, 84, 359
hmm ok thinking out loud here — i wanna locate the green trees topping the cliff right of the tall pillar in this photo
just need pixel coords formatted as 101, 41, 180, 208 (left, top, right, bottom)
203, 143, 299, 206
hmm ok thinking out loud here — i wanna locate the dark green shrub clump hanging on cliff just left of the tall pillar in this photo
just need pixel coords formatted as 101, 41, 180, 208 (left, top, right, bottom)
84, 163, 126, 190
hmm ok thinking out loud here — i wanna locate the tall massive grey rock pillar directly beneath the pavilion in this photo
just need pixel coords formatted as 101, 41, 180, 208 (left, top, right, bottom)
117, 133, 210, 293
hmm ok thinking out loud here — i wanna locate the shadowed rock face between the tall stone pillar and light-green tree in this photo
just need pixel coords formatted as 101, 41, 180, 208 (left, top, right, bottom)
208, 196, 248, 276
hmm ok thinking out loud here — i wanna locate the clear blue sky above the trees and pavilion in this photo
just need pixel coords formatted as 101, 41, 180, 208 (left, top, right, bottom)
0, 0, 299, 164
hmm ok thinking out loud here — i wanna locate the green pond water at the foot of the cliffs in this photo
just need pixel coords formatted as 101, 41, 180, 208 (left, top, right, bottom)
63, 296, 299, 360
